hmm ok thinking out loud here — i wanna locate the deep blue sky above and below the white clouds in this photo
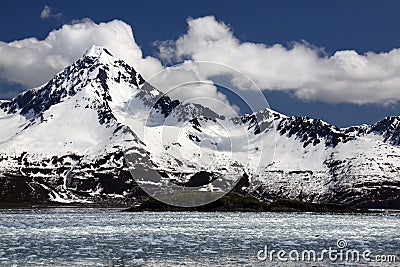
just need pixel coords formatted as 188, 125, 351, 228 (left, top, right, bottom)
0, 0, 400, 126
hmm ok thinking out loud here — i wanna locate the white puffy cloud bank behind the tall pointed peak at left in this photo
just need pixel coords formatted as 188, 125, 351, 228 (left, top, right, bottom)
0, 18, 234, 115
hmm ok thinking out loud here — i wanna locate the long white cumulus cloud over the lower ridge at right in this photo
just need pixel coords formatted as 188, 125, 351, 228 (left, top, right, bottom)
158, 16, 400, 104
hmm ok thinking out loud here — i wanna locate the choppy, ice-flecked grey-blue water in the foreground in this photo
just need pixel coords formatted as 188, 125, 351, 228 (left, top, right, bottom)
0, 208, 400, 266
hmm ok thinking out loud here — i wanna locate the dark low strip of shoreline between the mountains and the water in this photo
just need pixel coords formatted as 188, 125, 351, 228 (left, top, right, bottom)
0, 193, 400, 214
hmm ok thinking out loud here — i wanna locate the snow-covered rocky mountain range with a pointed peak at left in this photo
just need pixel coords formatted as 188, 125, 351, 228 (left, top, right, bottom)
0, 46, 400, 208
